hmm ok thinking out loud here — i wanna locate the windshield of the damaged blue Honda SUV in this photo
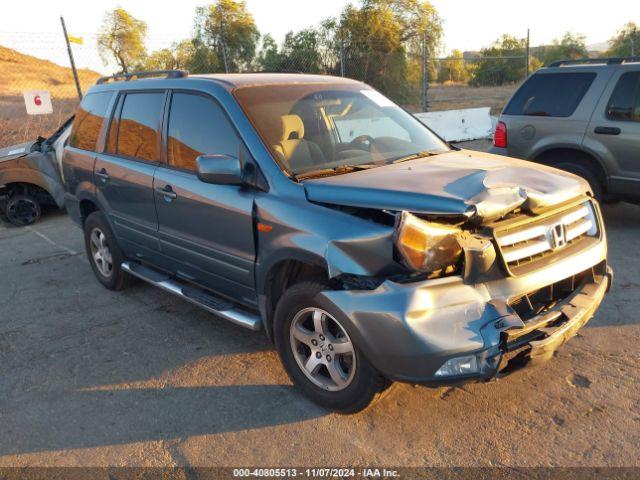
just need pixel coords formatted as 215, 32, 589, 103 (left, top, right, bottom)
234, 83, 449, 176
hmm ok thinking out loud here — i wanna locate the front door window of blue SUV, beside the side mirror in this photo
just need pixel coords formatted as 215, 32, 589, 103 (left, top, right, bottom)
167, 93, 240, 170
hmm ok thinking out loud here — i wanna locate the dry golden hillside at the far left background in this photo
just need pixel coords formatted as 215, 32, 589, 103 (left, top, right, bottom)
0, 46, 100, 98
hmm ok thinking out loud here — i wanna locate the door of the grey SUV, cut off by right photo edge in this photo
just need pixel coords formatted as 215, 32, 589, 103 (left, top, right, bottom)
585, 68, 640, 195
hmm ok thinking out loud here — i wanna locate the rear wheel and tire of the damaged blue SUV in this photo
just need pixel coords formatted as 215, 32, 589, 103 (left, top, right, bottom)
84, 212, 132, 290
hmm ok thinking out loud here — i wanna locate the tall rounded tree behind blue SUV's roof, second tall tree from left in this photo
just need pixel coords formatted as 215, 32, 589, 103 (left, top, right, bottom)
193, 0, 260, 72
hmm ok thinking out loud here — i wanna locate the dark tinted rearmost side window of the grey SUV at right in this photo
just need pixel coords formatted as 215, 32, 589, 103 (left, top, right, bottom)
504, 72, 596, 117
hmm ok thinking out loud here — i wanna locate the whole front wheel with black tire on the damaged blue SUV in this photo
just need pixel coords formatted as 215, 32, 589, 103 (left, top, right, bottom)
274, 282, 390, 413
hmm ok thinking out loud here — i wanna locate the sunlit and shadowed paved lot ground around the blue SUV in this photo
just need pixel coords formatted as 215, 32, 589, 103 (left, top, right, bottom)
0, 145, 640, 467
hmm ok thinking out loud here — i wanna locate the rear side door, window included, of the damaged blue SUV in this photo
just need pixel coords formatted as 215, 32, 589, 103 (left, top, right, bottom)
94, 90, 166, 259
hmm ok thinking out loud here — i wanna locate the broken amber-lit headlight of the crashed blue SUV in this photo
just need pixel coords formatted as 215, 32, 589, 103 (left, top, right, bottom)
395, 212, 462, 272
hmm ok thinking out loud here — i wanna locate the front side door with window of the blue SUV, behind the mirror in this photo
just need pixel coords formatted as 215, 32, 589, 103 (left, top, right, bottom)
154, 91, 255, 304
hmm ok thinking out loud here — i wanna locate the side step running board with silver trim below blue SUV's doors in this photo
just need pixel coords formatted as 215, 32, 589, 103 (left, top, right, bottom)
122, 262, 262, 330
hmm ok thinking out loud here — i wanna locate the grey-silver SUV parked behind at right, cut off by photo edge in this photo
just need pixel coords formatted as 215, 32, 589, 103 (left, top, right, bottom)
492, 57, 640, 201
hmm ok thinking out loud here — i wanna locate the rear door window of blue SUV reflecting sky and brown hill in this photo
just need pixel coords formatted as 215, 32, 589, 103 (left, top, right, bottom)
115, 92, 164, 162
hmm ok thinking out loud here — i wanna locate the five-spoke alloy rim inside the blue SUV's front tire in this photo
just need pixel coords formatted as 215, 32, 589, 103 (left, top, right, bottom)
290, 307, 356, 392
